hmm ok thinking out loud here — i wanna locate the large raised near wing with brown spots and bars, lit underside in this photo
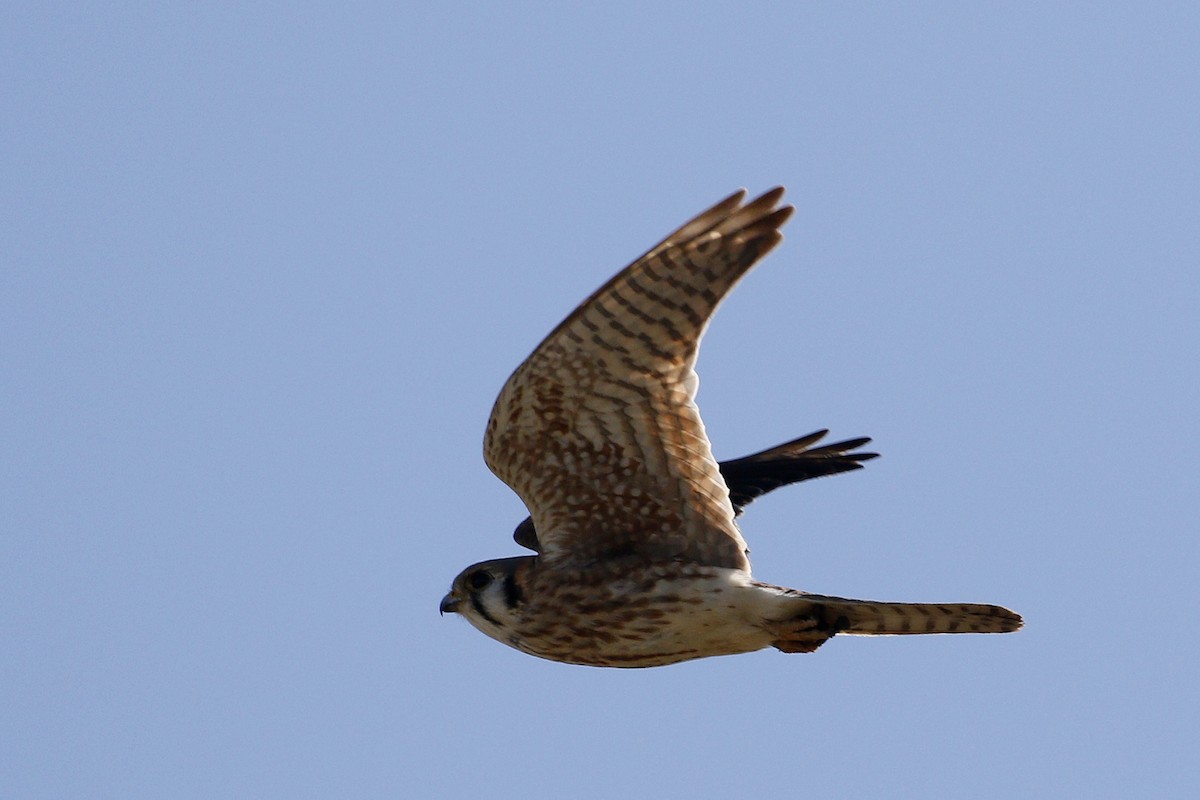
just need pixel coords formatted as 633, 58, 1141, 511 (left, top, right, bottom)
484, 188, 792, 569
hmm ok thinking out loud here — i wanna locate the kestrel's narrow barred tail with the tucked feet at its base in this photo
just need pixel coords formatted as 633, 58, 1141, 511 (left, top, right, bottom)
772, 595, 1024, 652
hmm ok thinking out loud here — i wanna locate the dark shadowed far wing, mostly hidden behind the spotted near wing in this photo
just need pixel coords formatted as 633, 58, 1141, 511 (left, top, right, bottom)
512, 431, 880, 553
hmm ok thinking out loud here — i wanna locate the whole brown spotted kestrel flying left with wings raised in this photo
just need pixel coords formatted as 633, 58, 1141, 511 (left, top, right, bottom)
440, 188, 1021, 667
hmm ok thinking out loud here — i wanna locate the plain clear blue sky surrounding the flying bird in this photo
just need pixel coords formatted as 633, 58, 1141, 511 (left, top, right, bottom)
0, 2, 1200, 800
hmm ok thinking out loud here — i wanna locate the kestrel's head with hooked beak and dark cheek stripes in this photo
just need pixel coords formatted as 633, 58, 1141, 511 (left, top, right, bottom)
438, 555, 536, 644
